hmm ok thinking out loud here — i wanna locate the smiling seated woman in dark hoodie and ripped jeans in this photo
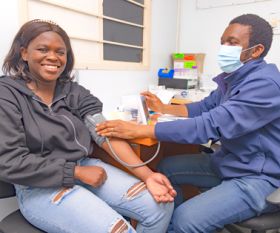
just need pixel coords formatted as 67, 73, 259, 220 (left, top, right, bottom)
0, 20, 176, 233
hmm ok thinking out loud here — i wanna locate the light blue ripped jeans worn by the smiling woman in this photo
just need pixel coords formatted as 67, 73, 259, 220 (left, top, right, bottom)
15, 158, 173, 233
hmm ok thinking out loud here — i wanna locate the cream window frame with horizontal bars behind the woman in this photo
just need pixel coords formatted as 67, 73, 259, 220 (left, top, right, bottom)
18, 0, 151, 70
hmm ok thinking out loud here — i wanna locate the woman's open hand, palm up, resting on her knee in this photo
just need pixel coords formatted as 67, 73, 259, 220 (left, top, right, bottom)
146, 173, 177, 202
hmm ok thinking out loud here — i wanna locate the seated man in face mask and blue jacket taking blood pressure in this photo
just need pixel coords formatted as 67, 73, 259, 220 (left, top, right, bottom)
97, 14, 280, 233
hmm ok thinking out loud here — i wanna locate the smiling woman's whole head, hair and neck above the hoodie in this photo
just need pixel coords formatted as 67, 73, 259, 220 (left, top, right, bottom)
3, 20, 74, 105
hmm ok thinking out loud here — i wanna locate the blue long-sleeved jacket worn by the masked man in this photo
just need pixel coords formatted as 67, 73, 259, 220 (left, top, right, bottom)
155, 59, 280, 187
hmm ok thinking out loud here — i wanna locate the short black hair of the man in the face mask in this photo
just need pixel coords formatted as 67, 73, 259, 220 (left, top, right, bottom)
229, 14, 273, 57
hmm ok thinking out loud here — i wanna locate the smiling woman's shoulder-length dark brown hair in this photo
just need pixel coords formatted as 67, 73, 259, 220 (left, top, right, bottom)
2, 19, 74, 82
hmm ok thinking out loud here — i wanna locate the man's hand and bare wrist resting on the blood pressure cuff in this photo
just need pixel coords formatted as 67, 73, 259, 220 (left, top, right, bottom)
96, 120, 154, 139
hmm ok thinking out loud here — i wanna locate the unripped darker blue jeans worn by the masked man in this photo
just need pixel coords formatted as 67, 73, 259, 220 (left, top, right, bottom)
158, 154, 278, 233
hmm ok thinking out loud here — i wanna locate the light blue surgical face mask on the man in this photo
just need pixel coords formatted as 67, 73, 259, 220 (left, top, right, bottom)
218, 45, 257, 73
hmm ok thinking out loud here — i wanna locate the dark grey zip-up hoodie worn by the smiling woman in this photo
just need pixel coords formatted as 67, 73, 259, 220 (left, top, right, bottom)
0, 76, 102, 187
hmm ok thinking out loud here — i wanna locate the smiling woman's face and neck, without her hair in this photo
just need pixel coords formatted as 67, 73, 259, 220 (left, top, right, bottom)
21, 31, 67, 105
